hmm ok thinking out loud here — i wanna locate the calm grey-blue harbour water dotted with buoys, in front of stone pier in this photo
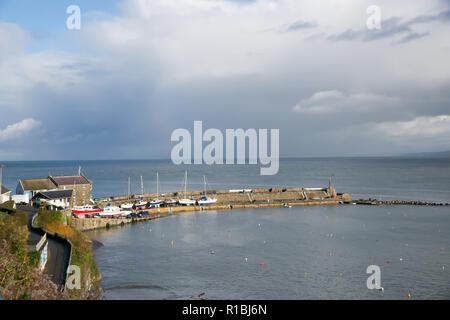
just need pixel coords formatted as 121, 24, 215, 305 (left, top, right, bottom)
88, 205, 450, 299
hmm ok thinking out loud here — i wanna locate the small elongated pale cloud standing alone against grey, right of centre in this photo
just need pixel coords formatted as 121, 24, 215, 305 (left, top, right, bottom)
293, 90, 399, 114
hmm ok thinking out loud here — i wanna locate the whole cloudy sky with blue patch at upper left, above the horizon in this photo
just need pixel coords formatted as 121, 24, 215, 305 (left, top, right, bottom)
0, 0, 450, 160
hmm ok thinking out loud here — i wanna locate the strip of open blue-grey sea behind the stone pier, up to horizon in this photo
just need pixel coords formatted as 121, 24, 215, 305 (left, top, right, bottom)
3, 158, 450, 201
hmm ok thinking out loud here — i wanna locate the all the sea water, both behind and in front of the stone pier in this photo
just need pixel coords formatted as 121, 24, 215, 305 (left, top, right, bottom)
3, 157, 450, 300
